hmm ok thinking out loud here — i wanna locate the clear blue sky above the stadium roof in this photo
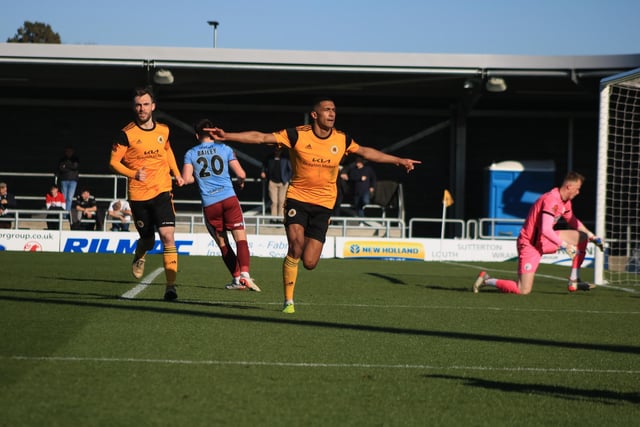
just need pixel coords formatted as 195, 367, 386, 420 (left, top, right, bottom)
0, 0, 640, 55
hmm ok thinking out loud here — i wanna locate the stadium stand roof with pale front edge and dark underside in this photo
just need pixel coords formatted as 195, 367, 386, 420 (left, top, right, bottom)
0, 43, 640, 115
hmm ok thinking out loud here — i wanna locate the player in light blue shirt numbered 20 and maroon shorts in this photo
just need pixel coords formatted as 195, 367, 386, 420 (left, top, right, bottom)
182, 119, 260, 292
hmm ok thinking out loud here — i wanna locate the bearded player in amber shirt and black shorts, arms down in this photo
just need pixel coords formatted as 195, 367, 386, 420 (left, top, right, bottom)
109, 88, 184, 301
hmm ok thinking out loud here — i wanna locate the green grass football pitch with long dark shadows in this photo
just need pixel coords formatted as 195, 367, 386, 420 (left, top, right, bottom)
0, 252, 640, 426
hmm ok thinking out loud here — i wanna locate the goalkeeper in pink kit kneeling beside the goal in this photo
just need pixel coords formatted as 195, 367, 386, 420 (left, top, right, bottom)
473, 172, 604, 295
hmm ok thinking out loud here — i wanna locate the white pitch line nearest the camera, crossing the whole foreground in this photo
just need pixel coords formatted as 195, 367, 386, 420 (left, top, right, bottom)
5, 356, 640, 375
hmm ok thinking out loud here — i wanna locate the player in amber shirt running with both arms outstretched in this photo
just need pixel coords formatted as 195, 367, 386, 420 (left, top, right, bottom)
205, 98, 421, 313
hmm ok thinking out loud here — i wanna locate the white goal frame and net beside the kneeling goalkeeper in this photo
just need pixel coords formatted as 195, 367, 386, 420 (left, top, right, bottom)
594, 68, 640, 287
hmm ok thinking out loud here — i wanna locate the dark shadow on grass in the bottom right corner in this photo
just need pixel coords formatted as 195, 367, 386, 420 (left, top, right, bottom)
423, 374, 640, 405
